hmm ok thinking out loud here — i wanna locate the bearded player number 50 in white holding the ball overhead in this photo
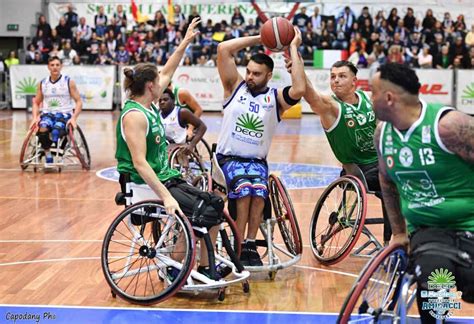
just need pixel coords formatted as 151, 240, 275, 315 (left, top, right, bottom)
216, 27, 306, 266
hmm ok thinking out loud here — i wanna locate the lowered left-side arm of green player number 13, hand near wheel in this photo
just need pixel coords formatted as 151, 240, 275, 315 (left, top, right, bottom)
374, 123, 409, 248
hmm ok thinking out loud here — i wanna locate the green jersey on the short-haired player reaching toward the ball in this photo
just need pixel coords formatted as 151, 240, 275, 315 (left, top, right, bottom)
326, 90, 377, 164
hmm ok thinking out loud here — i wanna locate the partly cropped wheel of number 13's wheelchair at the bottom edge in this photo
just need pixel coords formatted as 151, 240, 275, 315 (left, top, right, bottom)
337, 244, 408, 323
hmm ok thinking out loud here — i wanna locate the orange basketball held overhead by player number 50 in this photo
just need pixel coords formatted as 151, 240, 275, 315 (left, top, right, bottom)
260, 17, 295, 52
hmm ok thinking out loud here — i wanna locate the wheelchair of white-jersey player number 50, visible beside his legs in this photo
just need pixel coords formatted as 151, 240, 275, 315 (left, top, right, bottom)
211, 149, 303, 280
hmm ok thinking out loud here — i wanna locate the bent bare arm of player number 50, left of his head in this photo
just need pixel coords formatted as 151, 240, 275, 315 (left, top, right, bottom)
217, 36, 260, 98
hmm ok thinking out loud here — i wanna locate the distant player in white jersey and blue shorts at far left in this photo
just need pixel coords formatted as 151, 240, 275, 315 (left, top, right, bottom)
30, 56, 82, 163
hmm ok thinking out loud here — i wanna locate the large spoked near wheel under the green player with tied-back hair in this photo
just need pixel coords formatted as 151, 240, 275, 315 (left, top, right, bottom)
101, 200, 195, 305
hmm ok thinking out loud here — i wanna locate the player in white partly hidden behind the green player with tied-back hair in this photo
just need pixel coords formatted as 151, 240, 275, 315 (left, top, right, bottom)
158, 88, 207, 154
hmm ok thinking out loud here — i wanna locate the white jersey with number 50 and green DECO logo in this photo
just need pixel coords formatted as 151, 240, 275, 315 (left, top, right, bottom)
216, 81, 280, 159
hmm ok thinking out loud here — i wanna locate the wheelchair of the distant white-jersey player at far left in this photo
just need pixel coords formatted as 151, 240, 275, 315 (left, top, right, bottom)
20, 125, 91, 172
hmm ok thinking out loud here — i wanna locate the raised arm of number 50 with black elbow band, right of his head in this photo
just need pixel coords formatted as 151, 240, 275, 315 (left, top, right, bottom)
278, 26, 306, 113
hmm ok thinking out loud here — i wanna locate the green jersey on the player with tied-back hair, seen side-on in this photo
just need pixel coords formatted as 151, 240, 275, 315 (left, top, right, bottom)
115, 100, 181, 184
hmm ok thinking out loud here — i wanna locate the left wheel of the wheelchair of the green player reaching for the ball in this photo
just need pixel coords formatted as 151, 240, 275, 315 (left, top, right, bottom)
310, 176, 367, 265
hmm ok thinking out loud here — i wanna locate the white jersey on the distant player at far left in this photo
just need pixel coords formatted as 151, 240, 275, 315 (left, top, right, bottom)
41, 75, 74, 113
